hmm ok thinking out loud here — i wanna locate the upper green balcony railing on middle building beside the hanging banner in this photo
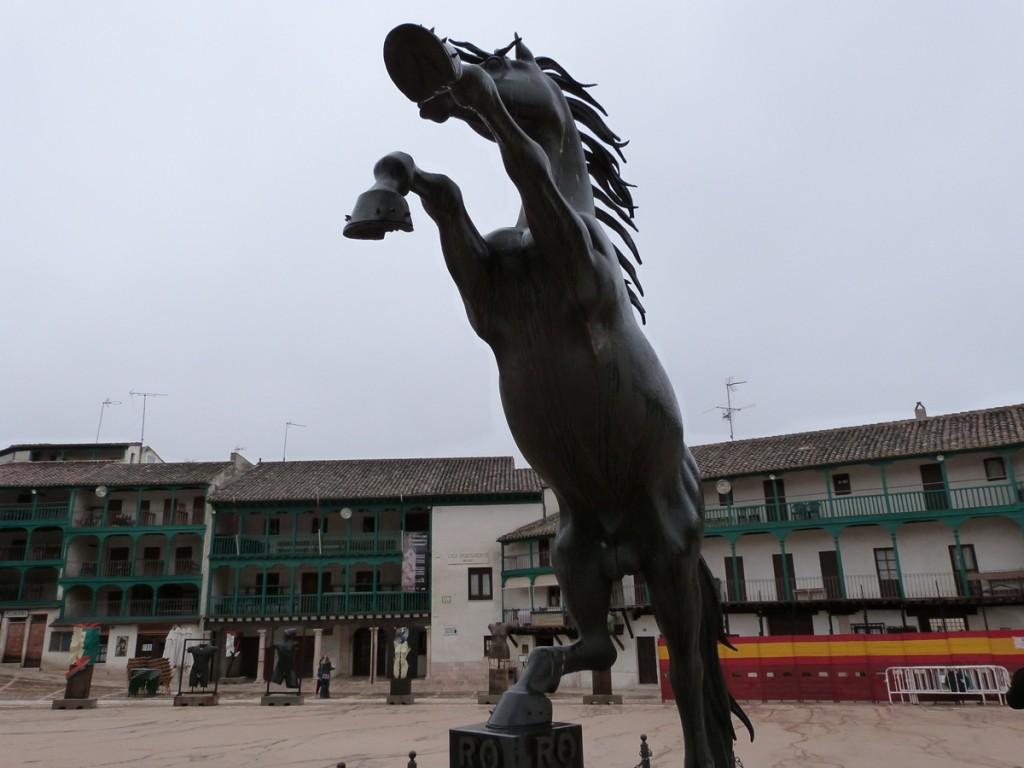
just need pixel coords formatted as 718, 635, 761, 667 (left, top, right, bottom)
210, 530, 401, 560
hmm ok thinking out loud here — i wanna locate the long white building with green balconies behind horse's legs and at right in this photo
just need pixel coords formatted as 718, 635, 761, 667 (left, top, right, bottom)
499, 403, 1024, 688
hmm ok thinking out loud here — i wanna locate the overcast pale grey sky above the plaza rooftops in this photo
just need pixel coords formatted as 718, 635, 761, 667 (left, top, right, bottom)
0, 0, 1024, 464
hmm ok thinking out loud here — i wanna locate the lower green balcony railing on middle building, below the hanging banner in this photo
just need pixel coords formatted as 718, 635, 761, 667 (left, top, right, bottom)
210, 592, 430, 616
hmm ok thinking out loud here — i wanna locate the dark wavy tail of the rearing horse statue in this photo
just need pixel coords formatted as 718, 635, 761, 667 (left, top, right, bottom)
698, 557, 754, 766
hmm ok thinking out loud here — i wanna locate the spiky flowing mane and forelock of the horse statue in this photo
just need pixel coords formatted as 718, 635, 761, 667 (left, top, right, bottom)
445, 35, 647, 325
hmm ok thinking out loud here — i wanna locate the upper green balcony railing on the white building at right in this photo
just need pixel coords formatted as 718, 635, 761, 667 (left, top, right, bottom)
705, 483, 1024, 528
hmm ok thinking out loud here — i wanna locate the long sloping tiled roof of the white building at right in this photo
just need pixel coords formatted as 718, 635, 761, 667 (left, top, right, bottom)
691, 404, 1024, 479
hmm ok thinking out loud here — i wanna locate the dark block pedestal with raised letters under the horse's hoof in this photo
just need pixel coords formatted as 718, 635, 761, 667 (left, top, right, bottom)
449, 723, 583, 768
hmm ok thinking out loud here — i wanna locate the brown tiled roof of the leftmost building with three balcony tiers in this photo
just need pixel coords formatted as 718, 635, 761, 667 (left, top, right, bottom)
0, 462, 231, 487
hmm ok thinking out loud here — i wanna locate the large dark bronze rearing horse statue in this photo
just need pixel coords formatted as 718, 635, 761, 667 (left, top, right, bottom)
345, 25, 753, 768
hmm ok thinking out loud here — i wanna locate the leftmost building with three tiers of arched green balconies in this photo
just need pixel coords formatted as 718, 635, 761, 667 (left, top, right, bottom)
0, 454, 251, 669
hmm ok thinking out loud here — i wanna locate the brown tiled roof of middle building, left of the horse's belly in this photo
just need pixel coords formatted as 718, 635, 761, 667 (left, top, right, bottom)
211, 457, 541, 502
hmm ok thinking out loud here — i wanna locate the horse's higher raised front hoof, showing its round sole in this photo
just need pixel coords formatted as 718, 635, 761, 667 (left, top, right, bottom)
384, 24, 462, 103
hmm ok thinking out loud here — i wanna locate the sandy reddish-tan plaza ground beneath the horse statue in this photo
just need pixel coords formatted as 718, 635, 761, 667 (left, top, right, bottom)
0, 668, 1024, 768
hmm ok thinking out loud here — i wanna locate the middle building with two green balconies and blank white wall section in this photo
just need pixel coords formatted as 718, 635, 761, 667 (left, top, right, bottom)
206, 458, 543, 685
